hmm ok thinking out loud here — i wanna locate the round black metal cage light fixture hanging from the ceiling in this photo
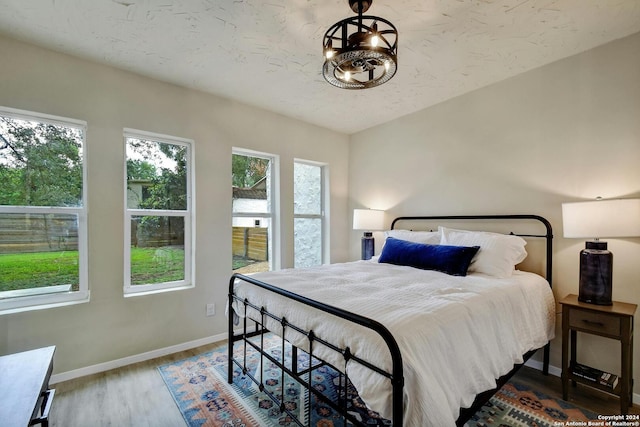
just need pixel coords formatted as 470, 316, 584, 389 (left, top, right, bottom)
322, 0, 398, 89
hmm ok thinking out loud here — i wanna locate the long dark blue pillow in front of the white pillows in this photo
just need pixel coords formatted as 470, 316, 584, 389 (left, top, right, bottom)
378, 237, 480, 276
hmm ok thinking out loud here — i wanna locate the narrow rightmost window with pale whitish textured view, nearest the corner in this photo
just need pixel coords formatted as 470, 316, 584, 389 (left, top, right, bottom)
293, 161, 326, 268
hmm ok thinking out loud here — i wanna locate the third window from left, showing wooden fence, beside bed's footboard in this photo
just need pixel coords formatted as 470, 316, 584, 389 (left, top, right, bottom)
232, 150, 277, 274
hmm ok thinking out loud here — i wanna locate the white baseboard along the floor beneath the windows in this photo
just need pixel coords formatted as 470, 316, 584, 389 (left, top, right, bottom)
50, 333, 227, 384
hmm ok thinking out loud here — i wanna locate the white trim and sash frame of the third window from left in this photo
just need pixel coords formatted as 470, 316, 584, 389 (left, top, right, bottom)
231, 147, 282, 271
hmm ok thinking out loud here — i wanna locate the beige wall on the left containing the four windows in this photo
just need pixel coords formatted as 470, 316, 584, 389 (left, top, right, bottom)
0, 38, 349, 373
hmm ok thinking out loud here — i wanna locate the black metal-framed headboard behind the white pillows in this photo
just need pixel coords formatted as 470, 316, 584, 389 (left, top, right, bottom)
391, 214, 553, 286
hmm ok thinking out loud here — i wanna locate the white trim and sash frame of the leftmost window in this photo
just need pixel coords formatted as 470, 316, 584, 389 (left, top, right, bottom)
0, 107, 90, 315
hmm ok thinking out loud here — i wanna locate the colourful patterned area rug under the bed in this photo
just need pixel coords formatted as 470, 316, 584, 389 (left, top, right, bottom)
158, 338, 597, 427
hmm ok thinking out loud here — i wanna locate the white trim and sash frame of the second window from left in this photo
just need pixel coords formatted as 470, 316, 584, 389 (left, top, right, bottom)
123, 128, 195, 297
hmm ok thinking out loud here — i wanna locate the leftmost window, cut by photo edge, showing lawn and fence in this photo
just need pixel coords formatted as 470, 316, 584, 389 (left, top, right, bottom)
0, 107, 89, 313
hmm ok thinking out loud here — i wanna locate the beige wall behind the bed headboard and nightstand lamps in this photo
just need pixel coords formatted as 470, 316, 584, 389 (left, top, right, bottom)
349, 34, 640, 378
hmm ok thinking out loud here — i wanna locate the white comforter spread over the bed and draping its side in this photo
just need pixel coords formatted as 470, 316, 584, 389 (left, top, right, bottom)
234, 261, 555, 427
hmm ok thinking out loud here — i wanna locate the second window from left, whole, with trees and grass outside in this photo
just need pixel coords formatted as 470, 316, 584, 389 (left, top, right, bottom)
124, 129, 193, 295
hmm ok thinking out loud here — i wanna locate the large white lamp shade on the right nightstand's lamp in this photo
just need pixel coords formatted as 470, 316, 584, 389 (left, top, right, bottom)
562, 199, 640, 239
